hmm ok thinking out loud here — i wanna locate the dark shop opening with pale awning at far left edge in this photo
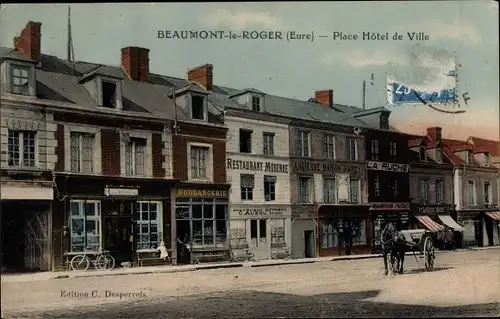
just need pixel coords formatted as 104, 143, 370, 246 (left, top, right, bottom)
0, 171, 54, 273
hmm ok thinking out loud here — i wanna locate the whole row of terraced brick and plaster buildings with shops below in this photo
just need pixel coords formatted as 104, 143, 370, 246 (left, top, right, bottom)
0, 22, 500, 270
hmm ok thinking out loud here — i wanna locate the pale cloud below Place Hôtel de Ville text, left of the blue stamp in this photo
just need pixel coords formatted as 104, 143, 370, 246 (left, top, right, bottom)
322, 49, 408, 68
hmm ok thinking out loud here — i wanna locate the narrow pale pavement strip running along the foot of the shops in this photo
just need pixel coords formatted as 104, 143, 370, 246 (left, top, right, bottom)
1, 246, 500, 282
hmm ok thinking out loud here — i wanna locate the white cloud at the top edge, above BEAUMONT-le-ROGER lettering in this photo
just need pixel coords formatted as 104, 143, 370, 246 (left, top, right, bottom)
204, 9, 281, 30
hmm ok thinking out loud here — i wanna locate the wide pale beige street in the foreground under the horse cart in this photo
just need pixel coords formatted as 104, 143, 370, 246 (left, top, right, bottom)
2, 249, 500, 318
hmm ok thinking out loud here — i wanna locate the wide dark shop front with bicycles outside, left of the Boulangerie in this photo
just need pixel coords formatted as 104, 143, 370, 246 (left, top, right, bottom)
54, 174, 171, 268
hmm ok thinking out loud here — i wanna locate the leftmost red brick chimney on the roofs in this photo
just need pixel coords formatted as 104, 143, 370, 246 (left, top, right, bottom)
14, 21, 42, 61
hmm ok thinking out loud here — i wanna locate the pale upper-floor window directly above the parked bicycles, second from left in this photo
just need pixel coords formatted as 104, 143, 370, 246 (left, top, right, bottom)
70, 132, 94, 173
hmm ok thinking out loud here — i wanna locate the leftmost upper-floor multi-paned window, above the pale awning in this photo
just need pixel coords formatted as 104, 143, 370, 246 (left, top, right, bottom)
7, 130, 36, 167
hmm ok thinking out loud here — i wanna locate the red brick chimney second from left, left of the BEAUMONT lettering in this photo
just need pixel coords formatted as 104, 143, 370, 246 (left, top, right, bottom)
122, 47, 149, 82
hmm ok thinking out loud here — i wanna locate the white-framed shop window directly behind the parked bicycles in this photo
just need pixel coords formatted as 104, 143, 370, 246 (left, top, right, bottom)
69, 200, 101, 252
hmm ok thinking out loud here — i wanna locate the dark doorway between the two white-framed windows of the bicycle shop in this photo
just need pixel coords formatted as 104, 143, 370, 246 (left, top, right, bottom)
103, 216, 134, 265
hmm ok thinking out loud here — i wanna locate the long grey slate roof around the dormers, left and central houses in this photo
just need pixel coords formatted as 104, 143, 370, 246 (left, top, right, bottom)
0, 47, 394, 128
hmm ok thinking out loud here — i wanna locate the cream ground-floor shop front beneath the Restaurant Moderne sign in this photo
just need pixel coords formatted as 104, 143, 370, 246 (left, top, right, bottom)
229, 204, 291, 260
